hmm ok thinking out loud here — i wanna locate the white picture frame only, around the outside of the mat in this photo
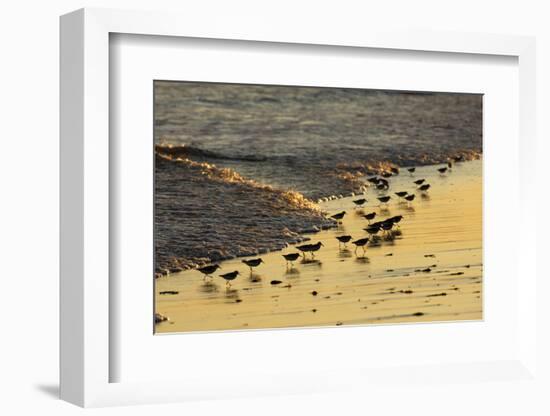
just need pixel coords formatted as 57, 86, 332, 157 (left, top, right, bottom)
60, 9, 539, 407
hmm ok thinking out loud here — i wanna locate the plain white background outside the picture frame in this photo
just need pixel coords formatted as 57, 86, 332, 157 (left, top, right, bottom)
0, 0, 550, 415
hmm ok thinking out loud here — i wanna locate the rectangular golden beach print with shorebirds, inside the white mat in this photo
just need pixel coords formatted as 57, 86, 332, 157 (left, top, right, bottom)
153, 80, 483, 333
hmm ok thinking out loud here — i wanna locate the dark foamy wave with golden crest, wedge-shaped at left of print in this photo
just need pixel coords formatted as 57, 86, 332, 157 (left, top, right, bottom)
155, 153, 335, 278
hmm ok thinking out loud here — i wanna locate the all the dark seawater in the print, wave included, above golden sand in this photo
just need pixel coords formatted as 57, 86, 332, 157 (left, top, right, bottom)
155, 81, 482, 272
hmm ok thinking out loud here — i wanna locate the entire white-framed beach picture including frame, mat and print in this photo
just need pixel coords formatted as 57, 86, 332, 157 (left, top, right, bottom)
61, 9, 539, 406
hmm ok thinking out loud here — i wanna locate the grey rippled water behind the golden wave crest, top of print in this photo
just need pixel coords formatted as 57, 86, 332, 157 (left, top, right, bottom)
155, 81, 482, 199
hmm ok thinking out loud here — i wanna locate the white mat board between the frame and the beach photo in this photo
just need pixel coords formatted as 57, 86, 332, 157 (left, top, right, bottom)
110, 35, 525, 386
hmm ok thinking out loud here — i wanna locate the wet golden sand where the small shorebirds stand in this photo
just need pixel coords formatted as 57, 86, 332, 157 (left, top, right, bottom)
155, 160, 482, 332
